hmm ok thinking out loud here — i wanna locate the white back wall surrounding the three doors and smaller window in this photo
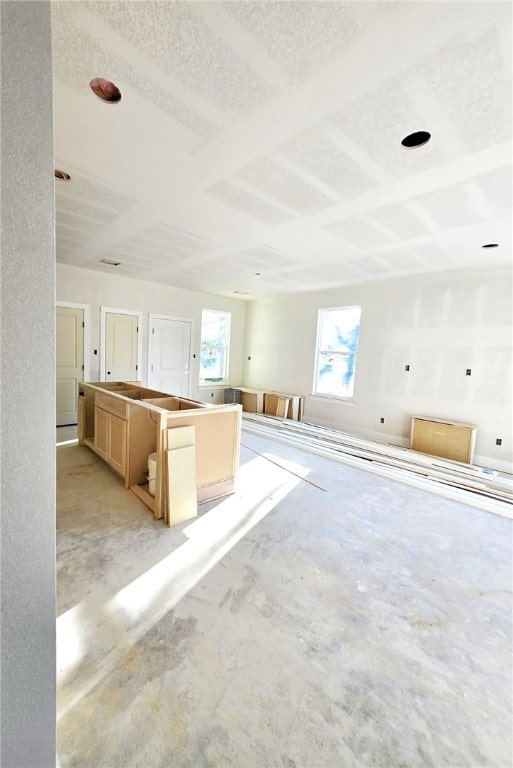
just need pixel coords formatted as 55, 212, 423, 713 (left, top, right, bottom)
57, 264, 246, 403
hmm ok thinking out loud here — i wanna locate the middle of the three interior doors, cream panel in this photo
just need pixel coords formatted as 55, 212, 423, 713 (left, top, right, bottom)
105, 312, 139, 381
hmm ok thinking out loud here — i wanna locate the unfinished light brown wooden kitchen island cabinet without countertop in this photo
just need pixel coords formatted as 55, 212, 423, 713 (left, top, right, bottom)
78, 382, 242, 525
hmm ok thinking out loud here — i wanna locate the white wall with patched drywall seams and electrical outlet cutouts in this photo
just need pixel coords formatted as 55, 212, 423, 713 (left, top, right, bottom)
244, 270, 513, 471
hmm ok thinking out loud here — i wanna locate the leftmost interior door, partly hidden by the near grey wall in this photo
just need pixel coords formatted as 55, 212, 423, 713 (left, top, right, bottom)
56, 307, 84, 427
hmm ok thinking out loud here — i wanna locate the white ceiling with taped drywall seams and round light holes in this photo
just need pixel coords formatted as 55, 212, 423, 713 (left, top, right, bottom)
52, 0, 512, 299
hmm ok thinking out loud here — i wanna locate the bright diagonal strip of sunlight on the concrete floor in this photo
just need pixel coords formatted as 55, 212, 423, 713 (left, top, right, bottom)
57, 457, 309, 719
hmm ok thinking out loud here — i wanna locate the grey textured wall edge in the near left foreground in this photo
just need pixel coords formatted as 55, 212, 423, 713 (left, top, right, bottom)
0, 2, 55, 768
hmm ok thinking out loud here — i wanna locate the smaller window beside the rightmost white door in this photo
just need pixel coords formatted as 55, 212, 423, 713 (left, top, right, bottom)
200, 309, 230, 384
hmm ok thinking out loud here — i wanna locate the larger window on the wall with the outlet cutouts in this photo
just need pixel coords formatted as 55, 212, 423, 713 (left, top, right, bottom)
314, 307, 361, 398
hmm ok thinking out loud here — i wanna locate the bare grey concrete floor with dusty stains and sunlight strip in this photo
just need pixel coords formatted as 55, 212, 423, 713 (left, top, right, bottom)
57, 434, 513, 768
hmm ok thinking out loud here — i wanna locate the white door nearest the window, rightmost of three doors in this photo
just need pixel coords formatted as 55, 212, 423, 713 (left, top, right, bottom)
148, 317, 191, 397
